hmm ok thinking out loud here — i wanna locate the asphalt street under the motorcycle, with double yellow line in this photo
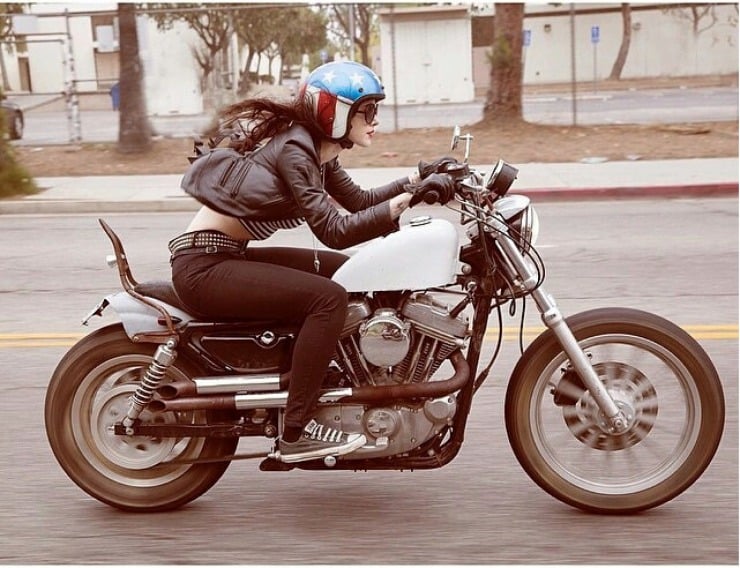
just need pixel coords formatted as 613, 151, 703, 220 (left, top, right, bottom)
0, 199, 738, 565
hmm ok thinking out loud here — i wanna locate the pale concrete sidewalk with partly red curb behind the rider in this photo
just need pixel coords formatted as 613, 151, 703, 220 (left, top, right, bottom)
0, 158, 738, 214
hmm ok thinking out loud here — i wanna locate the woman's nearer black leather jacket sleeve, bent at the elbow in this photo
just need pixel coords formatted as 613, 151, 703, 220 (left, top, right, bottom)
277, 141, 398, 249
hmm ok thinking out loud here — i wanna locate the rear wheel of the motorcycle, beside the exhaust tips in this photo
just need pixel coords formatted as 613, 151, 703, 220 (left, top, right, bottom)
45, 324, 238, 511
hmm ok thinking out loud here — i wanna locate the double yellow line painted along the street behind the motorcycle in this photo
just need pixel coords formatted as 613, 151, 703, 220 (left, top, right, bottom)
0, 324, 738, 349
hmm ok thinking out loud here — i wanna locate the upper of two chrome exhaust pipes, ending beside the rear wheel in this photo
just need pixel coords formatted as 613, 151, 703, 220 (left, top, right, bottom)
157, 374, 288, 400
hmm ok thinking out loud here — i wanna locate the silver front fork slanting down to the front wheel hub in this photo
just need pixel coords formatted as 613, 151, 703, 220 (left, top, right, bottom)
496, 229, 629, 434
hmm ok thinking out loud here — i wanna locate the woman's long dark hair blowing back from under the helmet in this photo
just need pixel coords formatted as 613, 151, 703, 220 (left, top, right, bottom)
219, 97, 325, 152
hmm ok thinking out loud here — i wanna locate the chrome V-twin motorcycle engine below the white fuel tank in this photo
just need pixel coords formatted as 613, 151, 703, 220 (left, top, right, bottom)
319, 293, 469, 460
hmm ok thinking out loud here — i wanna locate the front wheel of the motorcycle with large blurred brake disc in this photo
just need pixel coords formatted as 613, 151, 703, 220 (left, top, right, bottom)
506, 308, 724, 513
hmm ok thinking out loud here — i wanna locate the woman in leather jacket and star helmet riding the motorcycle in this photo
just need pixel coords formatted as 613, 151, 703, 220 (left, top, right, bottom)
169, 61, 454, 463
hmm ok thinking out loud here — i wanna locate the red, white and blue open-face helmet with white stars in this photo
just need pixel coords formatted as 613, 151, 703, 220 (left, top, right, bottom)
299, 61, 385, 141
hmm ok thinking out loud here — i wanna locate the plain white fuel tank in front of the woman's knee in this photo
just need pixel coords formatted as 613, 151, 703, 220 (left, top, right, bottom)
332, 217, 459, 292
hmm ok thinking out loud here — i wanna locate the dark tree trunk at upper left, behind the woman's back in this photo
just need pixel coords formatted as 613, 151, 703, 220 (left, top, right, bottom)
118, 4, 152, 154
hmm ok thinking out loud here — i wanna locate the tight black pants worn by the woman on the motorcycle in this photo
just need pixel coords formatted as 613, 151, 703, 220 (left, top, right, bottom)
172, 247, 347, 428
